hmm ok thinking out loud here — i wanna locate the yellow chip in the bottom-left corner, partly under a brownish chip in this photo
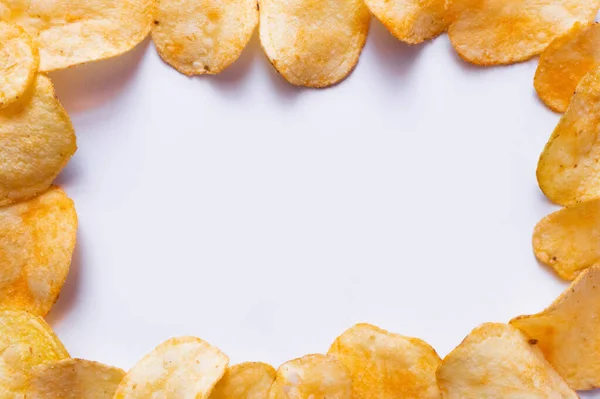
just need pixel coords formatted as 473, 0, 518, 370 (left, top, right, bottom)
0, 310, 69, 399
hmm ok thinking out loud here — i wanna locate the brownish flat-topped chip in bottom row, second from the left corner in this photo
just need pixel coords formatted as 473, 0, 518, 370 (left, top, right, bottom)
27, 359, 125, 399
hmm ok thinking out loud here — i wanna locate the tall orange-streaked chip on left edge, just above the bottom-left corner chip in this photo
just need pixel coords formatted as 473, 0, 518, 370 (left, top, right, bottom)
0, 187, 77, 316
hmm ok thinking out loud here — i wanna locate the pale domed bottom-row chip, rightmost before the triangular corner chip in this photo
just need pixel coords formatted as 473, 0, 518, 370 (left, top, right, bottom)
437, 323, 578, 399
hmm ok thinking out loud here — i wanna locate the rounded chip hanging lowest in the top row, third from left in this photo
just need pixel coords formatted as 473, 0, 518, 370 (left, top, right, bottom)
259, 0, 370, 87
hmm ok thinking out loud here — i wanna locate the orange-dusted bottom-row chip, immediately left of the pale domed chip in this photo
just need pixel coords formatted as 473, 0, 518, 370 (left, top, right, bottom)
329, 324, 441, 399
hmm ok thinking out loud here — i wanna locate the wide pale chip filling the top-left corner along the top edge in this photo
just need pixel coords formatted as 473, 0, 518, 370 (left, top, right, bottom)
0, 0, 155, 72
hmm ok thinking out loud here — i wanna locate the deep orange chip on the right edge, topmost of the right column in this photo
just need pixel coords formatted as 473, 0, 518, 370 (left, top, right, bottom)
533, 23, 600, 112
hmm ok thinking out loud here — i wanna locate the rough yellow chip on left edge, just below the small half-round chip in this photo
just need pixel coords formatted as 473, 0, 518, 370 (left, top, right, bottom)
0, 75, 77, 206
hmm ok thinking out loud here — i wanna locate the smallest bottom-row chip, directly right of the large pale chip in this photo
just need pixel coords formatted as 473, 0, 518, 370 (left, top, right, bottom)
210, 363, 275, 399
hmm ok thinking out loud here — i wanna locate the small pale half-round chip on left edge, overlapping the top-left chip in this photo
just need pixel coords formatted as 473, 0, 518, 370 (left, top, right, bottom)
0, 22, 40, 108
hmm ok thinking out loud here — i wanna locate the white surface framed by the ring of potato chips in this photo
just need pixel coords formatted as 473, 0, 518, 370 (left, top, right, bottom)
45, 23, 596, 396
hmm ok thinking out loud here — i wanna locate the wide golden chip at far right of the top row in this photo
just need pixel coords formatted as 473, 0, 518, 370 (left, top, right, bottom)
448, 0, 600, 65
